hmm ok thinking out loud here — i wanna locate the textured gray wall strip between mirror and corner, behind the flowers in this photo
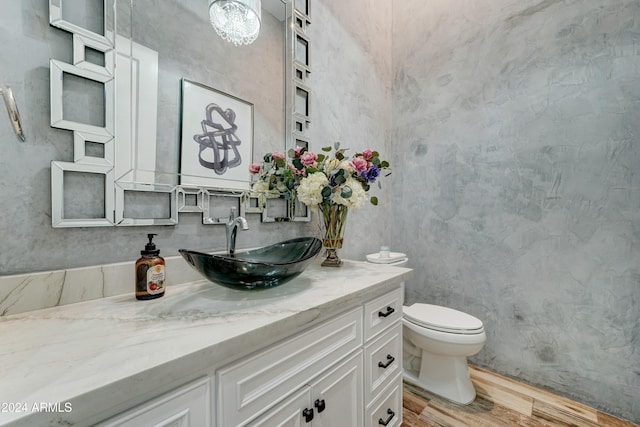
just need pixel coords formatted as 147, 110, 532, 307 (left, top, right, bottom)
310, 0, 397, 260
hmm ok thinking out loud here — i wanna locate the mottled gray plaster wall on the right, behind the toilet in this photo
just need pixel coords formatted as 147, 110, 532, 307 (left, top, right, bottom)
393, 0, 640, 421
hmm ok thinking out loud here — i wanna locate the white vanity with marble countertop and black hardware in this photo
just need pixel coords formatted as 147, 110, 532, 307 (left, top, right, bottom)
0, 260, 411, 427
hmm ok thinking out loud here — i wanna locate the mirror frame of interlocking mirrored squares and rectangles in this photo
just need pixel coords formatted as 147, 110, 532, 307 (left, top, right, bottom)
49, 0, 311, 228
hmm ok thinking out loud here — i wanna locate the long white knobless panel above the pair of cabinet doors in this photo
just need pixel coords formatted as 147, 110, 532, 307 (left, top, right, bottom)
216, 308, 363, 426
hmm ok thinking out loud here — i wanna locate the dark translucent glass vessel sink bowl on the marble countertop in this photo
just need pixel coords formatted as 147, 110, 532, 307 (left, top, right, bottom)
179, 237, 322, 290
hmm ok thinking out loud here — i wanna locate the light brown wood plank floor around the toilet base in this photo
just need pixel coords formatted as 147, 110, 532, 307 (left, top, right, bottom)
401, 366, 640, 427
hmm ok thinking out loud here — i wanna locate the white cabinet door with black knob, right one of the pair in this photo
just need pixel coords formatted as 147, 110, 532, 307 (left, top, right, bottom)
311, 351, 364, 427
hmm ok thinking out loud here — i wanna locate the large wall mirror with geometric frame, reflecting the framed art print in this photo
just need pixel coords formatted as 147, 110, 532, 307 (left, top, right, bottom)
49, 0, 311, 227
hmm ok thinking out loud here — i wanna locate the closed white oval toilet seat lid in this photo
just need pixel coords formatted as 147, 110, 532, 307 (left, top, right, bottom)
403, 304, 484, 334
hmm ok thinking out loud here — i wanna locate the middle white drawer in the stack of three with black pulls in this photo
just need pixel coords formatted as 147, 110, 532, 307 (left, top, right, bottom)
364, 323, 402, 402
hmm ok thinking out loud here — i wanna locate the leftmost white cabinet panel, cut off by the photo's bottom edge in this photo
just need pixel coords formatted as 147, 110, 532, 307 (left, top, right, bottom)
97, 378, 213, 427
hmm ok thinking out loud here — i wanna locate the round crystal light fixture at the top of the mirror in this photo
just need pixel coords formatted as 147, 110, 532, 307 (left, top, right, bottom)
209, 0, 262, 46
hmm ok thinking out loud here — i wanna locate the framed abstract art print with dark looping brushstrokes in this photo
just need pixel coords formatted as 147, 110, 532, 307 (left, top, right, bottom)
180, 79, 253, 190
